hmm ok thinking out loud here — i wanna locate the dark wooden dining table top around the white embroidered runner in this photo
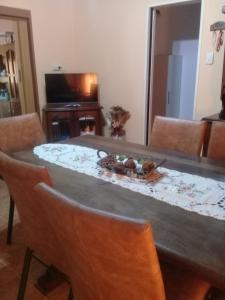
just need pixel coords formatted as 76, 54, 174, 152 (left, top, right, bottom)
14, 136, 225, 290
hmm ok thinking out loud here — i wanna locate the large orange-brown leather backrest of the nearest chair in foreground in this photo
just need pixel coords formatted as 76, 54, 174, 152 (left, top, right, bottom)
35, 183, 165, 300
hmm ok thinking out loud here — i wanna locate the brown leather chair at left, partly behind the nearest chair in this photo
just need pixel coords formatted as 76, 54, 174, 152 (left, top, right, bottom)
0, 151, 67, 300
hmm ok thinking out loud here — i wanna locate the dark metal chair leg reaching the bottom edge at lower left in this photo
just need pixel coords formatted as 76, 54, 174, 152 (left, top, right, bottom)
17, 247, 33, 300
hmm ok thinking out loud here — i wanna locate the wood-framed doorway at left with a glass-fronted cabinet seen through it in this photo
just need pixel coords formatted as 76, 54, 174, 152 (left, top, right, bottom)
0, 6, 39, 117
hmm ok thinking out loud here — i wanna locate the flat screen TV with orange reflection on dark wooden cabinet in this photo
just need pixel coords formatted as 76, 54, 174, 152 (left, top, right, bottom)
45, 73, 98, 103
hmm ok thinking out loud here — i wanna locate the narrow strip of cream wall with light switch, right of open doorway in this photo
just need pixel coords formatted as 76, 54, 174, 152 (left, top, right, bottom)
195, 0, 225, 119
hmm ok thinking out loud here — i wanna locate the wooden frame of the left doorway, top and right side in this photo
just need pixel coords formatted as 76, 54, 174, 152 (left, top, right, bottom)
0, 5, 40, 116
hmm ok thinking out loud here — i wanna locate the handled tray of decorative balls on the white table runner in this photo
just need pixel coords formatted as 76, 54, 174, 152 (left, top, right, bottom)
97, 149, 166, 182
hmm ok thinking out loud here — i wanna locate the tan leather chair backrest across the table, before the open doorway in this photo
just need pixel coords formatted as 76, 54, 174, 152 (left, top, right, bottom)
150, 116, 207, 155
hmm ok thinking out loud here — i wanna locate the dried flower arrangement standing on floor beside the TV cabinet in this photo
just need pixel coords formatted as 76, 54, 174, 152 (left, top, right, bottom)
107, 105, 130, 139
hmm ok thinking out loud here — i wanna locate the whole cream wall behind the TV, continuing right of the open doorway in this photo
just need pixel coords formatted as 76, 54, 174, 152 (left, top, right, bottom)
0, 0, 225, 143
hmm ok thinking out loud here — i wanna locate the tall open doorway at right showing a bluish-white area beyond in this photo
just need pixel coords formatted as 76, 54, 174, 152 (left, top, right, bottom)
147, 1, 201, 144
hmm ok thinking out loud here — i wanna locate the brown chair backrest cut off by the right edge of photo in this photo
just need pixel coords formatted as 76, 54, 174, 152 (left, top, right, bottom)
207, 122, 225, 160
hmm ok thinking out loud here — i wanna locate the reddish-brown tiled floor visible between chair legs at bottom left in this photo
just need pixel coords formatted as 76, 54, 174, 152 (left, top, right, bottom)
0, 181, 69, 300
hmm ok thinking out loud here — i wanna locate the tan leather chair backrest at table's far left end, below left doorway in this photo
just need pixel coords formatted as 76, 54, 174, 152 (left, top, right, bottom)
0, 113, 46, 153
